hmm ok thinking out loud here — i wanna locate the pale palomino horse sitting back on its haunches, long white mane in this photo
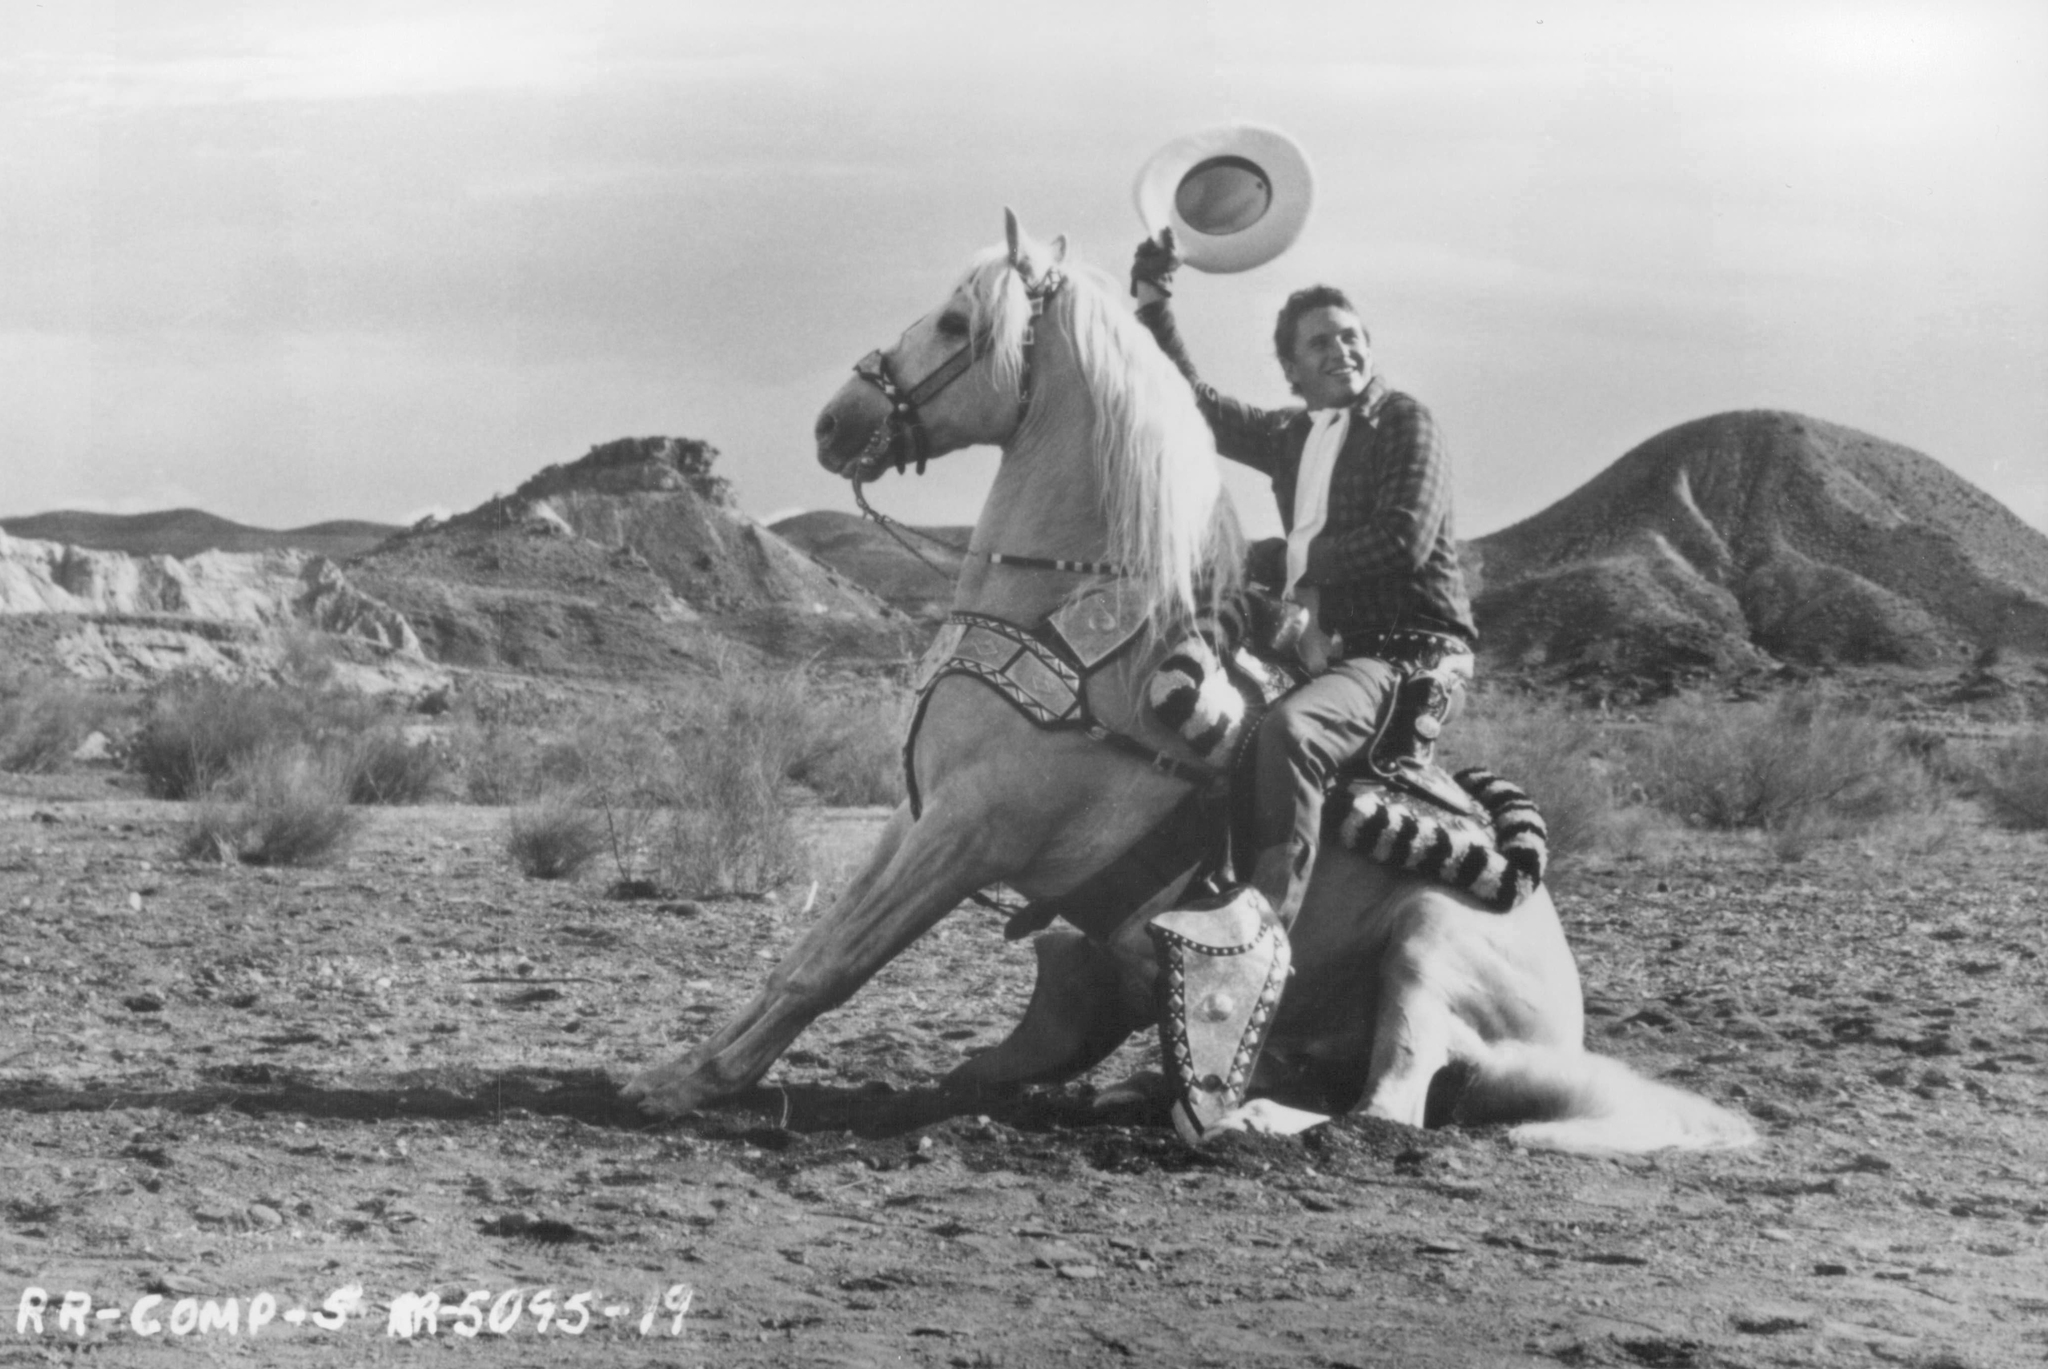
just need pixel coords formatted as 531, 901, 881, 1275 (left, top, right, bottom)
627, 215, 1755, 1154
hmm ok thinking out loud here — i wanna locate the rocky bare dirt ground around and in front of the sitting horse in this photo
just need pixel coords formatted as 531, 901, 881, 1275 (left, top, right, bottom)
0, 775, 2048, 1367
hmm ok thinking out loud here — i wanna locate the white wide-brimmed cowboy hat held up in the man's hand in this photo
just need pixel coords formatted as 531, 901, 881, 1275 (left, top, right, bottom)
1133, 123, 1315, 273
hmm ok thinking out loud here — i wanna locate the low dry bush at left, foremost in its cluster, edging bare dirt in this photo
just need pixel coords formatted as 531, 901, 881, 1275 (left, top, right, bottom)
180, 744, 356, 865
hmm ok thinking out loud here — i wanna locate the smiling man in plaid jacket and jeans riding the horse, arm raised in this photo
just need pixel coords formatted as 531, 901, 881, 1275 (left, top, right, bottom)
1130, 227, 1477, 926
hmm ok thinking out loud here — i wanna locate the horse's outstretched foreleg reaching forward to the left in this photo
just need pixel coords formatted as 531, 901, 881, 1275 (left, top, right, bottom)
625, 810, 1018, 1117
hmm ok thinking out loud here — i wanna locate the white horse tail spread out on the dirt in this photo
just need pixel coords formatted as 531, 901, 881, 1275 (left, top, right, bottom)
1456, 1041, 1757, 1156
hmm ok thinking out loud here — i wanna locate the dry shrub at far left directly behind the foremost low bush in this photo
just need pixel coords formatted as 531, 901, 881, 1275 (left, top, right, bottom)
129, 680, 313, 799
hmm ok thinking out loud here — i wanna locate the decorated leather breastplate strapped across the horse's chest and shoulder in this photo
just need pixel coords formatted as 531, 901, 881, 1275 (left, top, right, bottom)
903, 582, 1214, 818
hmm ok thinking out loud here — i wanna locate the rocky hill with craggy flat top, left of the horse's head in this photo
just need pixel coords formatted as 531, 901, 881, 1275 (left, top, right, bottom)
348, 437, 915, 676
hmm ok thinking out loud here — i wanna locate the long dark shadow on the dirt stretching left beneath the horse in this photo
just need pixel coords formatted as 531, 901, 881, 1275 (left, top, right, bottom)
0, 1064, 1450, 1174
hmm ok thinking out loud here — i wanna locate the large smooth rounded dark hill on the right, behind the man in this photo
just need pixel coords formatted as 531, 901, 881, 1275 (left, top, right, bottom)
1470, 410, 2048, 685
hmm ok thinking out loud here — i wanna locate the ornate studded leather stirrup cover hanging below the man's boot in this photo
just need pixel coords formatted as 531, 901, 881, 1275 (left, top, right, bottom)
1145, 887, 1292, 1146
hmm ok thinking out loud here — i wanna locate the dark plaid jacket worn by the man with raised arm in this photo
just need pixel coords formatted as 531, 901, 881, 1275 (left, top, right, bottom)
1139, 301, 1479, 641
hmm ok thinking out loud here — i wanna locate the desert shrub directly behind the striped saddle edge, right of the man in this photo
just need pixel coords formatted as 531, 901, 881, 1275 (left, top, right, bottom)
1438, 693, 1620, 863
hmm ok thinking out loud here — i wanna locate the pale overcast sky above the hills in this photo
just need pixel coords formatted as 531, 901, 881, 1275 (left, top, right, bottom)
0, 0, 2048, 535
